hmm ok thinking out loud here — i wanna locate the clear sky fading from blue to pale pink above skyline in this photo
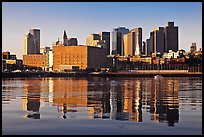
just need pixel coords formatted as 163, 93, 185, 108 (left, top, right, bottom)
2, 2, 202, 58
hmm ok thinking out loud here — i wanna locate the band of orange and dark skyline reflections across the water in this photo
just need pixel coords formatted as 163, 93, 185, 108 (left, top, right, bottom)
2, 77, 202, 126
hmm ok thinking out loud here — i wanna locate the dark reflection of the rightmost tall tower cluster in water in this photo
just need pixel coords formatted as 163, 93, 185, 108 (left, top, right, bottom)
150, 78, 179, 126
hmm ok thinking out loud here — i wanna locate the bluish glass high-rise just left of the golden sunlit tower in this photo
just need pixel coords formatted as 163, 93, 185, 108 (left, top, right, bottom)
110, 27, 129, 56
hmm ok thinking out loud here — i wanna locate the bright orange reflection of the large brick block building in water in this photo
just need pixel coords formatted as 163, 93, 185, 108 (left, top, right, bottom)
53, 78, 88, 119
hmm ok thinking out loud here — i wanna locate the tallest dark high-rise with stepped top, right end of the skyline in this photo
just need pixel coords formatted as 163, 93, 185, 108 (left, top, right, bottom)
164, 22, 179, 52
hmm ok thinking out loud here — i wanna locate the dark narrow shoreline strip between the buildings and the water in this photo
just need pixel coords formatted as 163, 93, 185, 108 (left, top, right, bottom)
2, 70, 202, 78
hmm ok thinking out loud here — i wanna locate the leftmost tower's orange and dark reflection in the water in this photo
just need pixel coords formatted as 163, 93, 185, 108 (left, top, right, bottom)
23, 79, 43, 119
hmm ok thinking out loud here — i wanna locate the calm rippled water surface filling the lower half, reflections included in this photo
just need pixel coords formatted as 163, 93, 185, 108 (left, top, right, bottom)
2, 77, 202, 134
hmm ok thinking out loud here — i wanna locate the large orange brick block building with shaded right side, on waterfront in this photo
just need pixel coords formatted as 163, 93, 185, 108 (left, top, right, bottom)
53, 45, 107, 71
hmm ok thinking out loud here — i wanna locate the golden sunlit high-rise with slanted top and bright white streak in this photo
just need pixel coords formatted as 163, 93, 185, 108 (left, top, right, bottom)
123, 27, 142, 56
